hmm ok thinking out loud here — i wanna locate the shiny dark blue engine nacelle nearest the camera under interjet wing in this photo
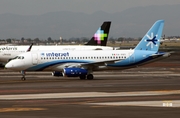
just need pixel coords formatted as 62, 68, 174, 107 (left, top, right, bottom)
64, 68, 88, 77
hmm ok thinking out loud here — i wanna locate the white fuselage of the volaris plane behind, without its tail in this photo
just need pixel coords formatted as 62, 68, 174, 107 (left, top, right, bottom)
0, 45, 113, 63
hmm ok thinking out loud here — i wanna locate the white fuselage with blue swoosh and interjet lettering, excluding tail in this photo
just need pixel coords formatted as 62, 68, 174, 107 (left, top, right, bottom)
6, 50, 135, 71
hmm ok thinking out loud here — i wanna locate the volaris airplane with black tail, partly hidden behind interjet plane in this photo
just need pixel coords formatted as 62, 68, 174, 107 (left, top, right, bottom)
0, 21, 113, 63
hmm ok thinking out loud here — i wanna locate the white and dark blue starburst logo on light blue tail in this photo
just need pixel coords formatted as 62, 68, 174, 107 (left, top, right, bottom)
145, 33, 159, 48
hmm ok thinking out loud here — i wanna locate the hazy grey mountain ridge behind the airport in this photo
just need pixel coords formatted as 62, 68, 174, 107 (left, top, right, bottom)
0, 4, 180, 39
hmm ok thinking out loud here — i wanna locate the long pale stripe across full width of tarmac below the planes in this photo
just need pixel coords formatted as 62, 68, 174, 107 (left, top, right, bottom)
0, 90, 180, 100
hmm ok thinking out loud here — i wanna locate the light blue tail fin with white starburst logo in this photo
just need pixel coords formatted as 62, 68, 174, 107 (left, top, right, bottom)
135, 20, 164, 51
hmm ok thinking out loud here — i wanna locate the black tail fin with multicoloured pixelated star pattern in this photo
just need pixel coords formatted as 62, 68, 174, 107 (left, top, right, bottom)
85, 21, 111, 46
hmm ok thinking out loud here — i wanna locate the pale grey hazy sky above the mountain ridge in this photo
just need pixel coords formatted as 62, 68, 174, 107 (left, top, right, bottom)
0, 0, 180, 15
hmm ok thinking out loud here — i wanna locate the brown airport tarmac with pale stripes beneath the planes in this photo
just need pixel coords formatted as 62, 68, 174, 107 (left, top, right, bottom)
0, 67, 180, 118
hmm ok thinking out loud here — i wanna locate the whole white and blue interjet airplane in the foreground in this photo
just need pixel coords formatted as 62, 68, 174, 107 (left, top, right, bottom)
5, 20, 170, 80
